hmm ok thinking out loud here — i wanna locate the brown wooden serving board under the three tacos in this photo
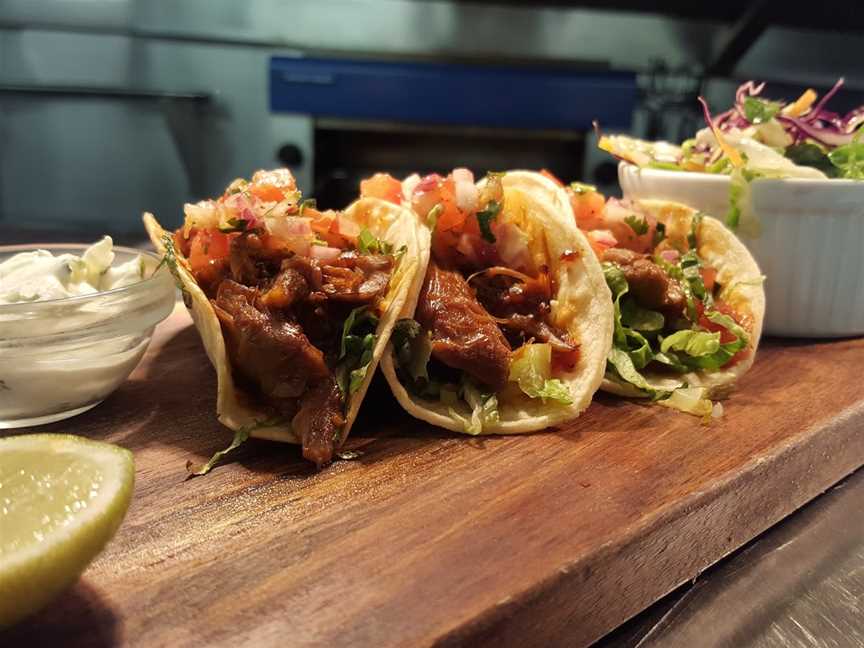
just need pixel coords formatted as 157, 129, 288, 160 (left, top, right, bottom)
0, 310, 864, 648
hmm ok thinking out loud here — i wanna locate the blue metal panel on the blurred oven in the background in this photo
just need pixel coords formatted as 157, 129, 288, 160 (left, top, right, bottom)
270, 57, 636, 130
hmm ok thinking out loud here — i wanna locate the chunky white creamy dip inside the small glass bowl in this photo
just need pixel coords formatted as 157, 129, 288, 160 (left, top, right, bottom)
0, 236, 144, 304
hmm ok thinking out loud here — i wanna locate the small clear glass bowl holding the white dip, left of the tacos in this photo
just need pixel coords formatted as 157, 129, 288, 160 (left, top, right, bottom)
0, 244, 175, 429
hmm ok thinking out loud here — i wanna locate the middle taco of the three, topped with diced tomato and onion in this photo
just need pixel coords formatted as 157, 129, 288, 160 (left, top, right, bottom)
361, 169, 612, 434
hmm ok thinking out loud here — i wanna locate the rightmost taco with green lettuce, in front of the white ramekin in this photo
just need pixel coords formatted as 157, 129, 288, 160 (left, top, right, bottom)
566, 177, 765, 416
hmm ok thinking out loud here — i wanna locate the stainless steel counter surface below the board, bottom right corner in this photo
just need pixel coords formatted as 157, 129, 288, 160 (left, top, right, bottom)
594, 469, 864, 648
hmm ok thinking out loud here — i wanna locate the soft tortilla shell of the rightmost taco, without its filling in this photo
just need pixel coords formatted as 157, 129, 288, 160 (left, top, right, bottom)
602, 200, 765, 398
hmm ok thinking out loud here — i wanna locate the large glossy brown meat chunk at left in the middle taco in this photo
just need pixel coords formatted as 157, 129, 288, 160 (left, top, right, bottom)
415, 261, 511, 391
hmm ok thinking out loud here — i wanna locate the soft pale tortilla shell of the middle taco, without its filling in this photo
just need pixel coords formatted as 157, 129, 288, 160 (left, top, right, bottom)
381, 171, 614, 434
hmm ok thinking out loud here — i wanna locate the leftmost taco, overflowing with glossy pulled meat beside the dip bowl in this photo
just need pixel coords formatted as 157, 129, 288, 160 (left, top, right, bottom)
144, 169, 429, 472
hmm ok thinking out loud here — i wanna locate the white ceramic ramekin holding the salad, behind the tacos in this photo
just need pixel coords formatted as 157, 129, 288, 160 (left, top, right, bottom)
618, 162, 864, 337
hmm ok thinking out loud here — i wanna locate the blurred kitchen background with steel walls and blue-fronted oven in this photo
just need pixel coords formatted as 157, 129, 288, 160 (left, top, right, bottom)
0, 0, 864, 243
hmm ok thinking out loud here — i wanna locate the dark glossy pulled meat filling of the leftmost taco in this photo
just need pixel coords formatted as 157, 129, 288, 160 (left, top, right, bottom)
190, 233, 395, 467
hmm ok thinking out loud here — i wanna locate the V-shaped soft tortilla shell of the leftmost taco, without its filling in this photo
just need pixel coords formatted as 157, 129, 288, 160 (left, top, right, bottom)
143, 198, 429, 446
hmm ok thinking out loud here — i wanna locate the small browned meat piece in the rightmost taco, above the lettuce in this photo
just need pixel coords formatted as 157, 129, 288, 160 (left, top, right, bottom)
602, 248, 687, 317
